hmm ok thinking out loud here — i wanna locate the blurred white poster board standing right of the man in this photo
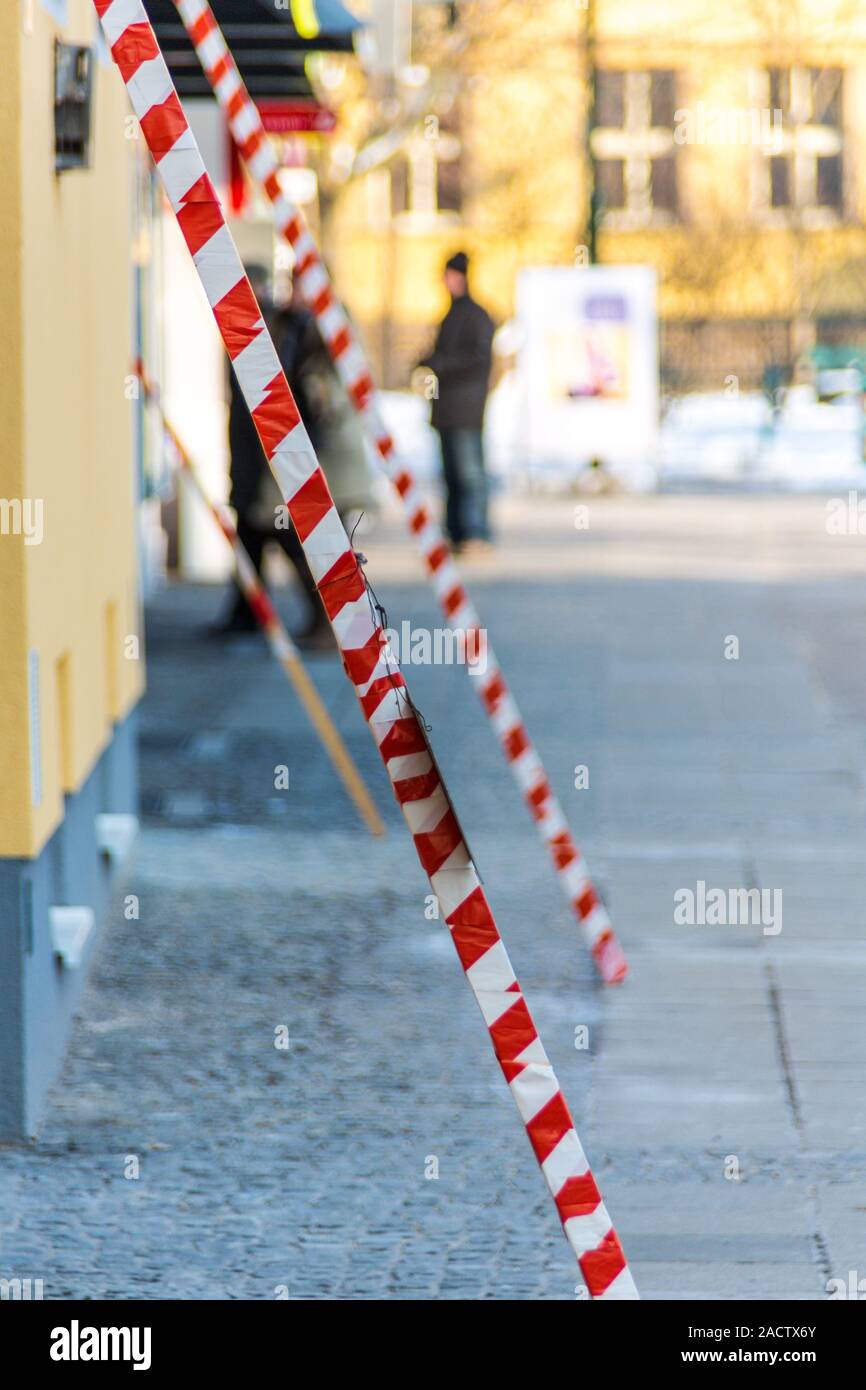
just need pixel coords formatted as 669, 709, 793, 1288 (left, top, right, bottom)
517, 265, 659, 487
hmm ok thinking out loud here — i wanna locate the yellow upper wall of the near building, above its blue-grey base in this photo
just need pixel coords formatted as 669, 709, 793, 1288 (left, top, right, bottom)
0, 0, 143, 856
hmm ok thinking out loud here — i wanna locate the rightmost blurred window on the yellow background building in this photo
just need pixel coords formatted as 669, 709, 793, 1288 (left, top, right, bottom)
756, 67, 845, 216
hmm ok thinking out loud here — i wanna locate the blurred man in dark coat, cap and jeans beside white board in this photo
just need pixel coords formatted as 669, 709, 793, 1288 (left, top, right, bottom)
418, 252, 493, 552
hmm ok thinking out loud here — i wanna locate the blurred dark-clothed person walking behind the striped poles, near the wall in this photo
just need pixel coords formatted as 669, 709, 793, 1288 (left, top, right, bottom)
214, 265, 375, 649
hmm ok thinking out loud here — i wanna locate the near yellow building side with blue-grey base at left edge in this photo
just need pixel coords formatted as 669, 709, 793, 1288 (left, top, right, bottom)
0, 0, 143, 1138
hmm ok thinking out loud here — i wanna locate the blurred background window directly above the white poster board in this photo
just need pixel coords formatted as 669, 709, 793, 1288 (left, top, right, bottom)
592, 68, 678, 229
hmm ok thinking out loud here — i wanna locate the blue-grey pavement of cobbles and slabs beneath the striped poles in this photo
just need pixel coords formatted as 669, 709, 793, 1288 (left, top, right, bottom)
0, 496, 866, 1300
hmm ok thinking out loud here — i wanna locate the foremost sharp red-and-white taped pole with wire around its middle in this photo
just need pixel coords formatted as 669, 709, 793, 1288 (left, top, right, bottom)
93, 0, 638, 1298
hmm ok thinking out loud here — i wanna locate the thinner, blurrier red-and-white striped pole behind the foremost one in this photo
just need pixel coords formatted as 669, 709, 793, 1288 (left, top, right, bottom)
174, 0, 627, 984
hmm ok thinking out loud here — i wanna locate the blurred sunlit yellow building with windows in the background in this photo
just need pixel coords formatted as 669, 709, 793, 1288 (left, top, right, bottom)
319, 0, 866, 389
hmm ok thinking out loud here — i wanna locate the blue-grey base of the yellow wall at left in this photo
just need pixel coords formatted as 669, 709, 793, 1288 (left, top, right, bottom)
0, 714, 138, 1143
